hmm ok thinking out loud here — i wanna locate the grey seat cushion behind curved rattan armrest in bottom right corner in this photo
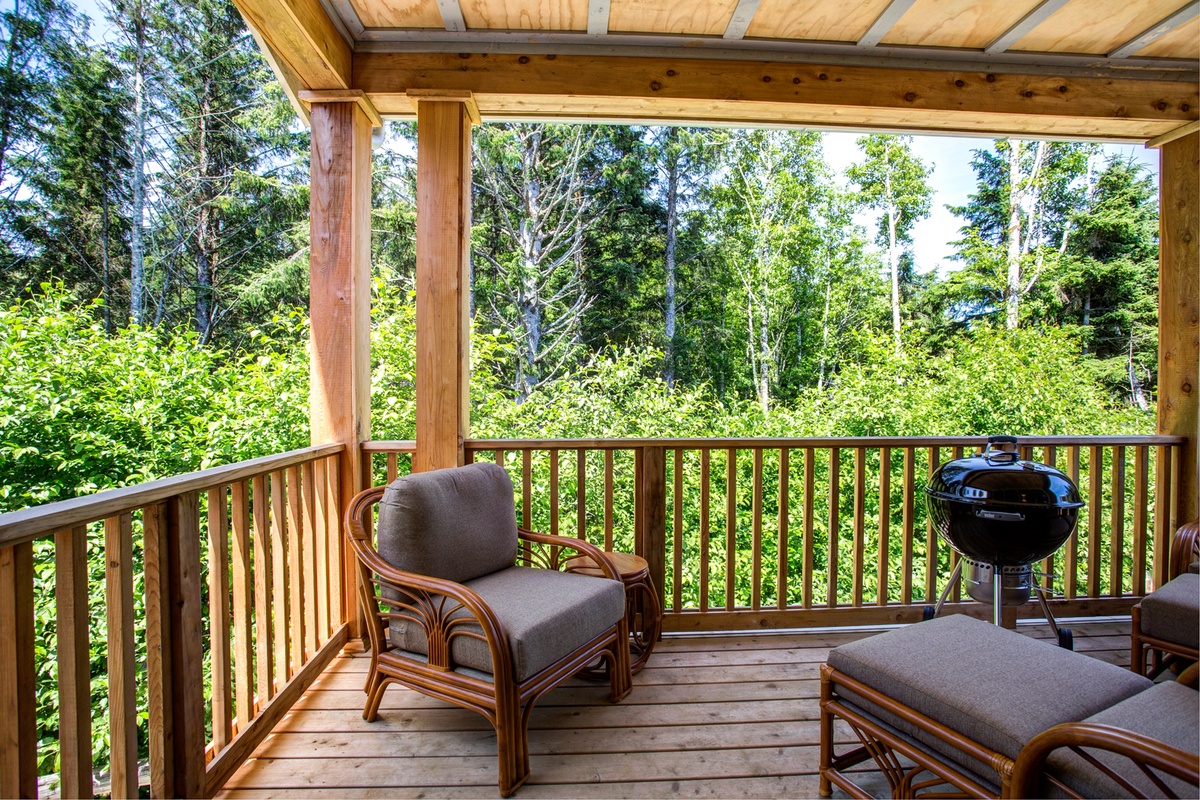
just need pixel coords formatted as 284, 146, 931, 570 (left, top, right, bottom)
1046, 681, 1200, 798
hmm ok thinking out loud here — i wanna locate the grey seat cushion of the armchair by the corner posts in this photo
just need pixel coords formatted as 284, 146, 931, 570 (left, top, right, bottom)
391, 566, 625, 682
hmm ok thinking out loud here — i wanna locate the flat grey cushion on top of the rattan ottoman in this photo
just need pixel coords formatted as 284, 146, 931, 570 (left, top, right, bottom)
829, 615, 1151, 775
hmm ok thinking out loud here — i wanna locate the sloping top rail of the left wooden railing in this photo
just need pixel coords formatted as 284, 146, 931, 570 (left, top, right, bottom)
0, 444, 346, 547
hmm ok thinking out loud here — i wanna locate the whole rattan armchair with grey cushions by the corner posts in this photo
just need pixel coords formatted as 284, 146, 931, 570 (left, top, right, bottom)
346, 463, 632, 796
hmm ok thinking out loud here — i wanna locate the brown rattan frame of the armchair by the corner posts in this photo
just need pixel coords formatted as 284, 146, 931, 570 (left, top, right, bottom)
346, 486, 632, 798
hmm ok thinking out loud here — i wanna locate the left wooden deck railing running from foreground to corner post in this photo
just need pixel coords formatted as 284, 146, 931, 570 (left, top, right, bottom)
0, 445, 347, 798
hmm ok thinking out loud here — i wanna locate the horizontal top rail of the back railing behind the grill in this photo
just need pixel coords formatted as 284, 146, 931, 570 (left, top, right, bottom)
362, 435, 1186, 452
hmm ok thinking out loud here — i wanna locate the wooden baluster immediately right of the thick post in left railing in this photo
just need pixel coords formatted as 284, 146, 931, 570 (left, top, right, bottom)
209, 487, 234, 752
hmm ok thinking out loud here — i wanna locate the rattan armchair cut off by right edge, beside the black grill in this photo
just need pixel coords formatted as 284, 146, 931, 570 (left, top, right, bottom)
1129, 521, 1200, 679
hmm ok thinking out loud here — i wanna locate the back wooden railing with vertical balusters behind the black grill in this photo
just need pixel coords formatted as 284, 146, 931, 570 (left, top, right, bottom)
364, 437, 1183, 631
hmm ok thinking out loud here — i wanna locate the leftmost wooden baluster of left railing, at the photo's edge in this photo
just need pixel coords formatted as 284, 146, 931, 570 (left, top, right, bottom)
0, 542, 37, 798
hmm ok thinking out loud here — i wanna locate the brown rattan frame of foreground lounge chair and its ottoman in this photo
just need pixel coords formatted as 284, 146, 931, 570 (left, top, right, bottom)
818, 664, 1200, 798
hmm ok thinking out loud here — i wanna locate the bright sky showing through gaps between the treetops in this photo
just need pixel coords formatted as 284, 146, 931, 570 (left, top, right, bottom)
74, 0, 1158, 275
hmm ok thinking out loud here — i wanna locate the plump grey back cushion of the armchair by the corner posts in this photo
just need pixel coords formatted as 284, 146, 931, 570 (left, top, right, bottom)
376, 463, 517, 583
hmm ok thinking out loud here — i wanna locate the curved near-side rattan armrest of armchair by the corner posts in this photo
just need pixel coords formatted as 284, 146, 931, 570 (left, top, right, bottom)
346, 486, 512, 681
